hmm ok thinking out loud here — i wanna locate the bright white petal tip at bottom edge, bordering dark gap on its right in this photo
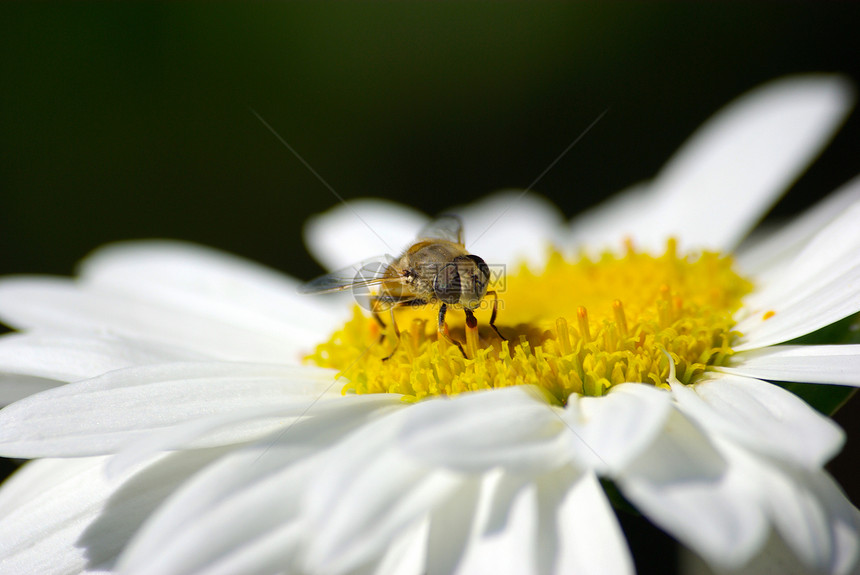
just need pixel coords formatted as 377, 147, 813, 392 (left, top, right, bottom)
555, 473, 634, 575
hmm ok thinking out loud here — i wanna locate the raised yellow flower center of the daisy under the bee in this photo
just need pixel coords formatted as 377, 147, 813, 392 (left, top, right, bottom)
308, 240, 752, 405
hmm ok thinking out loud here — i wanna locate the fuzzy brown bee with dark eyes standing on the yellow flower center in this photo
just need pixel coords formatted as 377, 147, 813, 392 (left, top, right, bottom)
299, 215, 505, 361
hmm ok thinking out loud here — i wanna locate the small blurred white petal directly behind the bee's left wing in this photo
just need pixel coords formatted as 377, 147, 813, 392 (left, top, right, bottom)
305, 199, 428, 270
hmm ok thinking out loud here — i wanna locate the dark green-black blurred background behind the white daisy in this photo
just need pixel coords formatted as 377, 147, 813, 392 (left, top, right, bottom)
0, 2, 860, 567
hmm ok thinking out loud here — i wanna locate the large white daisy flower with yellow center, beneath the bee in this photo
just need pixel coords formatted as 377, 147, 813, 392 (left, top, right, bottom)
0, 76, 860, 574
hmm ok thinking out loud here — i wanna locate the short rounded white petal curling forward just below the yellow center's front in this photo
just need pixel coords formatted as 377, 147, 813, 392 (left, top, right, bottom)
397, 386, 570, 472
